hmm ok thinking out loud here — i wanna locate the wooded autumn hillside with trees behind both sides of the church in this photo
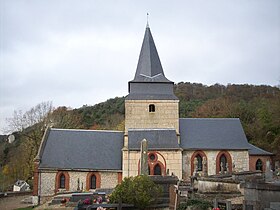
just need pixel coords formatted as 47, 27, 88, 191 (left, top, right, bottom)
0, 82, 280, 190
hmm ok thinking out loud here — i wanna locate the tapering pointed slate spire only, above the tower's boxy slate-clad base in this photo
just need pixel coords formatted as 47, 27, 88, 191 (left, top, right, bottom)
133, 23, 170, 82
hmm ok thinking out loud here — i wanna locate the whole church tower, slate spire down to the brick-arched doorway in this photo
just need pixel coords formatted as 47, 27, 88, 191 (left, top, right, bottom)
122, 25, 182, 177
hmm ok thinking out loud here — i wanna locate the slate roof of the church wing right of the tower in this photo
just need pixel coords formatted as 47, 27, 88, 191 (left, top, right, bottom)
180, 118, 249, 150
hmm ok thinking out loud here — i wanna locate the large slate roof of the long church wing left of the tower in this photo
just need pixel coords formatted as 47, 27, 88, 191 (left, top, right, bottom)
39, 129, 124, 170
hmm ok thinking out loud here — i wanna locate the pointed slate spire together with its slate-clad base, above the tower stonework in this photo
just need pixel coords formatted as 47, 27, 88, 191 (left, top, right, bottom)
126, 26, 178, 100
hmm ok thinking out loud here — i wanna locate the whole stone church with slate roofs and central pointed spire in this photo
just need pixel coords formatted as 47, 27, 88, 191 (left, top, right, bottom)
33, 25, 273, 197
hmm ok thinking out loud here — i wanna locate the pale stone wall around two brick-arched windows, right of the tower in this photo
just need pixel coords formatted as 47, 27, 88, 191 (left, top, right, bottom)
183, 150, 249, 179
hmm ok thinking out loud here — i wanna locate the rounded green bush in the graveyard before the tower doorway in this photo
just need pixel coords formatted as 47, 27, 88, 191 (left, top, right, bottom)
110, 175, 162, 209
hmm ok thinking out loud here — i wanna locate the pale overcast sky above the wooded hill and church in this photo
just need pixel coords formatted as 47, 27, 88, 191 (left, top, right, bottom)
0, 0, 280, 133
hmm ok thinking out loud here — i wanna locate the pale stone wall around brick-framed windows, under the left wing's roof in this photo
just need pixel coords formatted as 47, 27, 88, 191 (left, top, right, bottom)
38, 171, 119, 196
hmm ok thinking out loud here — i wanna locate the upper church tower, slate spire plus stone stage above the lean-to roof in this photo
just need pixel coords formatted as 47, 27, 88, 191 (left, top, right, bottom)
125, 25, 179, 134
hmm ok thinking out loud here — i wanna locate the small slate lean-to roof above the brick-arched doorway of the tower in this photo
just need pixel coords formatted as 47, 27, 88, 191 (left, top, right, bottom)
128, 129, 180, 150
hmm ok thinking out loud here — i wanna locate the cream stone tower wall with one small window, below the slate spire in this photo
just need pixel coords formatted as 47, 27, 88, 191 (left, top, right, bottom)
125, 100, 179, 133
